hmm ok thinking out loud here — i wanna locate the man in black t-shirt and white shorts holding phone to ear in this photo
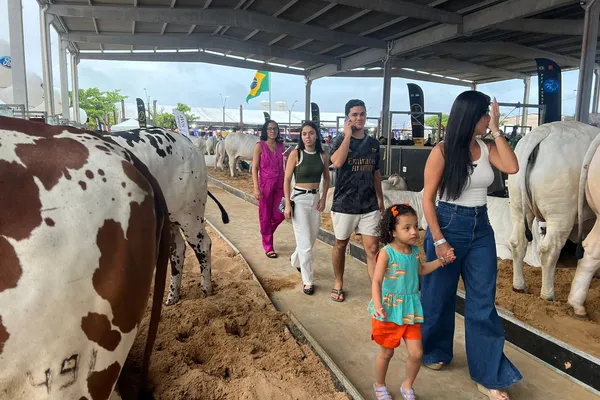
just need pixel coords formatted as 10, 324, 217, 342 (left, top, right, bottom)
329, 100, 384, 302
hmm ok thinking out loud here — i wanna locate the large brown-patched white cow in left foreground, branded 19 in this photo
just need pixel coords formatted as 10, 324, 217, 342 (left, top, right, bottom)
0, 117, 169, 400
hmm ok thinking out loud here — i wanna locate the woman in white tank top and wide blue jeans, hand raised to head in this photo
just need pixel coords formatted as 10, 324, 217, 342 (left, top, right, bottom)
421, 91, 522, 400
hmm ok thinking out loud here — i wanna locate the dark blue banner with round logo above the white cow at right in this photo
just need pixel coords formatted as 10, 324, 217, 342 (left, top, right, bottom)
535, 58, 562, 125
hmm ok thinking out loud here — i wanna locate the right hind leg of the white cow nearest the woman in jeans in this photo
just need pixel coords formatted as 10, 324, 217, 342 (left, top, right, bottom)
540, 225, 571, 301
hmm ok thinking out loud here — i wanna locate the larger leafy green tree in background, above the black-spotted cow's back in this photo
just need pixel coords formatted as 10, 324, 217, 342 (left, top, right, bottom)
69, 88, 127, 129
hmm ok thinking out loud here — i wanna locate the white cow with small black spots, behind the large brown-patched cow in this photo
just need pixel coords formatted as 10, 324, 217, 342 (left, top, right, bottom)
110, 128, 229, 305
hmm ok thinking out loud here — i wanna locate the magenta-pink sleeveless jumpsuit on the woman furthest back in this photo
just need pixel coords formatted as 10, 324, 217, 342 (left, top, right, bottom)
258, 140, 285, 253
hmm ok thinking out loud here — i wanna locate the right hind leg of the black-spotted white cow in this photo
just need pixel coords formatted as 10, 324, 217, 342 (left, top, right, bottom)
181, 216, 212, 296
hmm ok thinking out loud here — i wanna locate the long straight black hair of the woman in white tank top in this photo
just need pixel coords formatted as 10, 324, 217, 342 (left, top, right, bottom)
440, 90, 490, 200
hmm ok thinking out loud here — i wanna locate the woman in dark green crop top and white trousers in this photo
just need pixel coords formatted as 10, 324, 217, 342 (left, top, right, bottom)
283, 121, 329, 295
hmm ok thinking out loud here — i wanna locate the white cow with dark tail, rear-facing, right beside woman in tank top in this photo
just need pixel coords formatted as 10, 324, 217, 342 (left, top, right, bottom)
508, 121, 600, 300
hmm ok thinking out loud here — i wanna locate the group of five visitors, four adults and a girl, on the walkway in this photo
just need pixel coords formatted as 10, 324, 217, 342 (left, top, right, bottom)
252, 91, 522, 400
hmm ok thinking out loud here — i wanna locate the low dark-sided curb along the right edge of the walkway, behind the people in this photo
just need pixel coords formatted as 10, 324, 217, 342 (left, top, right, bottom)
208, 176, 600, 396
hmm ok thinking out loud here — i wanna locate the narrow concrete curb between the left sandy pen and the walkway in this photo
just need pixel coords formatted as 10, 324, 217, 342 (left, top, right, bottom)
206, 219, 364, 400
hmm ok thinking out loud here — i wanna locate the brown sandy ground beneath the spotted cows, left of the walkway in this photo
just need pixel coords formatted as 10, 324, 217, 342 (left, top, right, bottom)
119, 231, 347, 400
